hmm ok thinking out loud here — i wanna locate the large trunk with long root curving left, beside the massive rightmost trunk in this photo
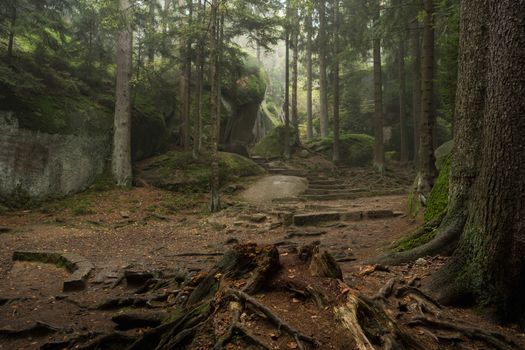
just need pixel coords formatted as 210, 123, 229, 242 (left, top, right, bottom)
376, 1, 487, 264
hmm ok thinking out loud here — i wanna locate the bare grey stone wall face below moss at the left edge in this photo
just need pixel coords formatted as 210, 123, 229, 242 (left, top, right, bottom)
0, 111, 111, 199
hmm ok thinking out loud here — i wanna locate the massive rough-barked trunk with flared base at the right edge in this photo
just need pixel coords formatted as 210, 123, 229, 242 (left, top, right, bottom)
431, 0, 525, 327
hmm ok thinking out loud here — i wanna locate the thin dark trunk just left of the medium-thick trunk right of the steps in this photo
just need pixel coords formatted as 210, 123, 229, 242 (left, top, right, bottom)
410, 20, 421, 166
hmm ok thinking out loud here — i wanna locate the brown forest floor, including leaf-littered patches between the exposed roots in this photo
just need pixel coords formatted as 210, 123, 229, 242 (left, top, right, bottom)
0, 157, 525, 350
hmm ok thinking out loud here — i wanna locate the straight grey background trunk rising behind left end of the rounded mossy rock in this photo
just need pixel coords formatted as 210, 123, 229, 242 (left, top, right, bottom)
318, 0, 328, 137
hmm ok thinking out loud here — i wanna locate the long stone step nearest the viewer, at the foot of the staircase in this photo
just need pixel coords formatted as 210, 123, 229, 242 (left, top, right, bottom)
292, 209, 392, 226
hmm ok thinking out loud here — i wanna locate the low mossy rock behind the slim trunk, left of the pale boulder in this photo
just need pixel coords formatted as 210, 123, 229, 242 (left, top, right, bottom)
138, 151, 264, 192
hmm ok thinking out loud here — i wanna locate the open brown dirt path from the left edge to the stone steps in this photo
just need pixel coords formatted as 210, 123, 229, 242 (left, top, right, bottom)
0, 165, 520, 349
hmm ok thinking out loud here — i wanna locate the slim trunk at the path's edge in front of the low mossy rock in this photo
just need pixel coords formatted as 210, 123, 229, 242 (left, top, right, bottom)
210, 0, 220, 213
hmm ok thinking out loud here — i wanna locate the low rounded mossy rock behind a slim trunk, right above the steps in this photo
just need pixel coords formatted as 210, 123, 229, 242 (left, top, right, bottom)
307, 133, 374, 166
